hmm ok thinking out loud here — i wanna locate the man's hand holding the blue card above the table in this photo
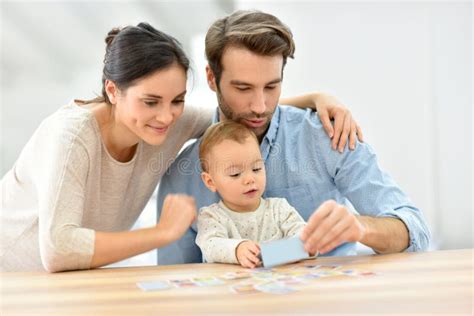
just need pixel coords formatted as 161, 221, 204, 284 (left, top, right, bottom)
301, 200, 365, 254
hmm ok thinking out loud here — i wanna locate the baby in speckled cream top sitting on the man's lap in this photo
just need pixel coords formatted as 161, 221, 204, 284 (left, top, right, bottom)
196, 121, 306, 268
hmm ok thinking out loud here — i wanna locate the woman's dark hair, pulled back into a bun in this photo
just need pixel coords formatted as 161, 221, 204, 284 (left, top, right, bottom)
83, 23, 189, 104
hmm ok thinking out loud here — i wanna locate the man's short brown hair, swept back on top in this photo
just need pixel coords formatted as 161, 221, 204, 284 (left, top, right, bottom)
206, 10, 295, 86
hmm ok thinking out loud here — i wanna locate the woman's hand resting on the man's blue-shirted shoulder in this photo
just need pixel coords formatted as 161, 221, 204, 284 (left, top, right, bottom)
314, 93, 364, 153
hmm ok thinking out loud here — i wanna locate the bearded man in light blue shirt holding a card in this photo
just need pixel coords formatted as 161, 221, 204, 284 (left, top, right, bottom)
158, 11, 430, 264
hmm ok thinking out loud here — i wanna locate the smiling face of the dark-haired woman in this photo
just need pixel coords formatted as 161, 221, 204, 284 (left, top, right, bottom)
113, 63, 186, 145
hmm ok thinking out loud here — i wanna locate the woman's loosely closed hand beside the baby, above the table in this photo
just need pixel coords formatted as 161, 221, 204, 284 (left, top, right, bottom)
156, 194, 197, 242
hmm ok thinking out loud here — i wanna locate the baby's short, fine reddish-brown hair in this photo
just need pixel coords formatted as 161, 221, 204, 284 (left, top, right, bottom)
199, 120, 258, 172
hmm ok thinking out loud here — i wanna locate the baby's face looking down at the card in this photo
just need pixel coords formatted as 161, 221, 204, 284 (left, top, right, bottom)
208, 137, 266, 212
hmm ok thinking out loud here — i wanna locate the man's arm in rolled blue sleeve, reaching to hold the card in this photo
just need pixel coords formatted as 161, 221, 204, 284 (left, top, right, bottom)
301, 116, 430, 254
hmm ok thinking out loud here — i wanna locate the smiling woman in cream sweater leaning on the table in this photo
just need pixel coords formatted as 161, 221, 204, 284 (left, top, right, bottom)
0, 23, 362, 272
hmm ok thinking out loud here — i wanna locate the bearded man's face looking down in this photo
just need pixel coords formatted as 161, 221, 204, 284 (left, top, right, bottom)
208, 47, 283, 140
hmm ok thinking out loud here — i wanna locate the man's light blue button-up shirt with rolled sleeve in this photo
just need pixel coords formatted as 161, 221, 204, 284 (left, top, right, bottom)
157, 106, 430, 264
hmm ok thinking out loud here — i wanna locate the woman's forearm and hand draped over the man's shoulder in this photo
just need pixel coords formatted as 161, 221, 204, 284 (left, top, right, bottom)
280, 92, 364, 152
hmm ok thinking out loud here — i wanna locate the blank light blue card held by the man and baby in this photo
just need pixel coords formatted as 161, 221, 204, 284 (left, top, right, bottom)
260, 236, 310, 267
